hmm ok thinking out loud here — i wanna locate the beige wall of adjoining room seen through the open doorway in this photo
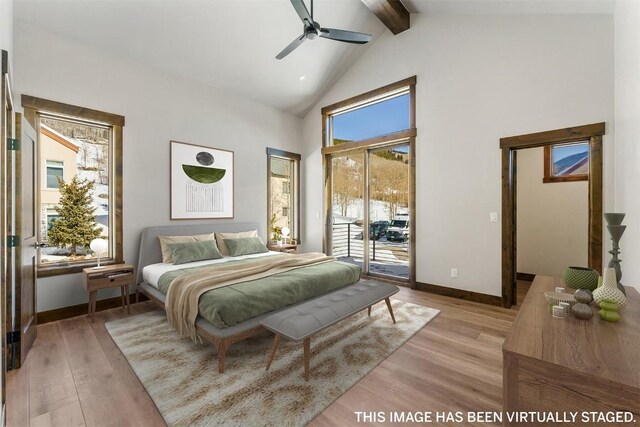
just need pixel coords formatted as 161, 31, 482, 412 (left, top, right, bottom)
516, 147, 589, 277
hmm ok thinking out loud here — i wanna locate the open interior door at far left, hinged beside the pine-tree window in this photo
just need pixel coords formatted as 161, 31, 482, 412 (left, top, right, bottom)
16, 113, 38, 365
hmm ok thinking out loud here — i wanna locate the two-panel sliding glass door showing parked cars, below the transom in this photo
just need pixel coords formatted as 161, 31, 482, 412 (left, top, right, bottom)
330, 142, 411, 280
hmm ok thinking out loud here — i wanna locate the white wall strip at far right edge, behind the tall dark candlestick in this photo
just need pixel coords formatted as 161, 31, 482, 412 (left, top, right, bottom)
616, 0, 640, 290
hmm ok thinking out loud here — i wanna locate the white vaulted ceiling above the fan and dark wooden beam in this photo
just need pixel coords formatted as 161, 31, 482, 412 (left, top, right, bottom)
14, 0, 613, 116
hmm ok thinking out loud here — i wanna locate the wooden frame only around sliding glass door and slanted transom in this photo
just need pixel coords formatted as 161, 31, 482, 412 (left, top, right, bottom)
321, 76, 418, 289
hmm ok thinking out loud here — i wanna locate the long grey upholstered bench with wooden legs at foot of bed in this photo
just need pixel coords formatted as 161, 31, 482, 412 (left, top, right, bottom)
260, 281, 398, 381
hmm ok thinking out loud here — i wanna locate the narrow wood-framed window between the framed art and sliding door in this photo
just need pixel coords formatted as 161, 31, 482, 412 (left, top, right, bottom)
267, 148, 300, 243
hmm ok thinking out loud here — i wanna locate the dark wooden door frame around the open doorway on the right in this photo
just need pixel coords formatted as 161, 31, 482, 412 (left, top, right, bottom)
500, 123, 605, 308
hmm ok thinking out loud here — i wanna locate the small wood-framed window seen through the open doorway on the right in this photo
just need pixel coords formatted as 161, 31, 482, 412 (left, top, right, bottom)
543, 141, 589, 183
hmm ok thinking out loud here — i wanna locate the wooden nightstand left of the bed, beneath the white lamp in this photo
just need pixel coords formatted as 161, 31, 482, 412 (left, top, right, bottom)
82, 264, 135, 322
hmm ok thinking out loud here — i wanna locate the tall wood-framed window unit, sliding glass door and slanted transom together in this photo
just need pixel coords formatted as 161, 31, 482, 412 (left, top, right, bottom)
322, 77, 417, 283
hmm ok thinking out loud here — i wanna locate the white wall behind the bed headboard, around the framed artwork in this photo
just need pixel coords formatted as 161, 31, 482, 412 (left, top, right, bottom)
14, 21, 301, 311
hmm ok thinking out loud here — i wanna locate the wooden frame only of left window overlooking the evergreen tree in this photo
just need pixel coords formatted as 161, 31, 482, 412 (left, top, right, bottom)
22, 95, 125, 278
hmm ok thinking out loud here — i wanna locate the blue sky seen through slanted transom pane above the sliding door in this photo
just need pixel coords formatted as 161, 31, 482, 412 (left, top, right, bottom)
333, 94, 409, 141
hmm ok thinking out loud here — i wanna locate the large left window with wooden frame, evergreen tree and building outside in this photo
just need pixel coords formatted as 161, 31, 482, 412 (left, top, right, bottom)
22, 95, 124, 277
